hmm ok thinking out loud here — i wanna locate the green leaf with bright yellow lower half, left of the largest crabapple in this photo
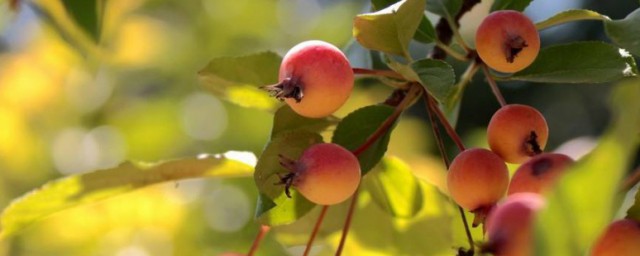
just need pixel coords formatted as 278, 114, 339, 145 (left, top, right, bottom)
198, 52, 282, 111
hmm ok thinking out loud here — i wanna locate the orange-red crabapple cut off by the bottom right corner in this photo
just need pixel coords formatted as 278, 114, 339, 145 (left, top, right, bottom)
591, 219, 640, 256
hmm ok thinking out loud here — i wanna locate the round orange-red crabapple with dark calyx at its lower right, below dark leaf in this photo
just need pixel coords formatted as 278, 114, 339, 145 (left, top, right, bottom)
487, 104, 549, 164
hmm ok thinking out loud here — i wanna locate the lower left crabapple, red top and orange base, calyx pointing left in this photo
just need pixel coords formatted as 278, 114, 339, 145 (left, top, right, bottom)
280, 143, 360, 205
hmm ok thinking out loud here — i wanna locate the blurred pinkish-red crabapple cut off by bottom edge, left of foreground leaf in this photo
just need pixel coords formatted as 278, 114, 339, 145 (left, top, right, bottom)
482, 193, 545, 256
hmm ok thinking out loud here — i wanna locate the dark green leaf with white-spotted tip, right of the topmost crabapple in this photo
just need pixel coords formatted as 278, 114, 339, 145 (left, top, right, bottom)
510, 42, 638, 83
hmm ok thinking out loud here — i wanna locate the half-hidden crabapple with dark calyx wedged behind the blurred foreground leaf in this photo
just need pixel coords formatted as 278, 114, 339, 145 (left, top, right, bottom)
507, 153, 574, 195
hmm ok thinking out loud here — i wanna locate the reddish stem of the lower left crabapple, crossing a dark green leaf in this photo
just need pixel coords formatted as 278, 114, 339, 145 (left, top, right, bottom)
352, 83, 423, 156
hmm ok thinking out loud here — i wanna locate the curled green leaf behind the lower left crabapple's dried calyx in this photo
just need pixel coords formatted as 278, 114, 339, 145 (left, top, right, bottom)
253, 130, 322, 226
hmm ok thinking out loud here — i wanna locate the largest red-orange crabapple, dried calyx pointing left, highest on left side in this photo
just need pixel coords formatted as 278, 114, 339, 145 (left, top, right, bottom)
262, 40, 354, 118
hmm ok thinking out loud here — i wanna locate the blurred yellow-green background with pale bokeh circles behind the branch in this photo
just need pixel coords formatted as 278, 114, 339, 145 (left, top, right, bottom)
0, 0, 638, 256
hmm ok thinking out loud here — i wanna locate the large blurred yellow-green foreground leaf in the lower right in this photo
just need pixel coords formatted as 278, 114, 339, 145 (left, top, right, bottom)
536, 79, 640, 255
